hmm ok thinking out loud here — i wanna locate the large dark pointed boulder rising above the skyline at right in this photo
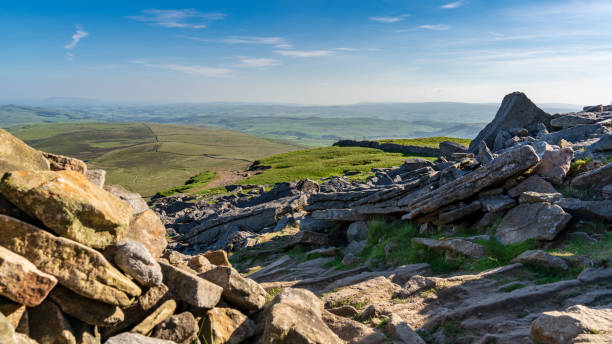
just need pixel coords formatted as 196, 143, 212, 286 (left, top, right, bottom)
468, 92, 551, 153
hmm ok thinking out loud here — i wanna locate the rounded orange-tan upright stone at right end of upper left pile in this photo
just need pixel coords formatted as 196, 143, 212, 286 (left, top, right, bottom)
127, 209, 168, 259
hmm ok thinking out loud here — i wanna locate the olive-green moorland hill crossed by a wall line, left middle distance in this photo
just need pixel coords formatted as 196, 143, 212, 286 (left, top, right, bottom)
8, 123, 302, 197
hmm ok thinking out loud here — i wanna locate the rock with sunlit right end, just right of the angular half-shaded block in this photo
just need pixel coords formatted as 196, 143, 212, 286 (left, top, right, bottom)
199, 266, 267, 312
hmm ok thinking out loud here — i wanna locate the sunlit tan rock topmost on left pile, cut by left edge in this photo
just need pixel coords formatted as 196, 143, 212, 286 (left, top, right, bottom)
0, 128, 49, 176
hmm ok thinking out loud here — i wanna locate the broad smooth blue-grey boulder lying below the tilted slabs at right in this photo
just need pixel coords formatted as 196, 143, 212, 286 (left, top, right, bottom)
495, 203, 572, 245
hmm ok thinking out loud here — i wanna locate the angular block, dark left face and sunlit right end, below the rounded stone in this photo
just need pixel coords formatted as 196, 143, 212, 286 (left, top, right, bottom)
160, 262, 223, 308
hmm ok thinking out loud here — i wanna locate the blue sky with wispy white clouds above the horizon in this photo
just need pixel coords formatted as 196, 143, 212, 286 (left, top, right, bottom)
0, 0, 612, 105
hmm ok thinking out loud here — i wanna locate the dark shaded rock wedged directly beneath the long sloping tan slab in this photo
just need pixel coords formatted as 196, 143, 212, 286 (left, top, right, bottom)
49, 286, 124, 326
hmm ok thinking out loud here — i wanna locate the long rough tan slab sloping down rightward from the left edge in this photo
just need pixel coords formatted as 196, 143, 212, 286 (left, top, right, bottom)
0, 215, 141, 306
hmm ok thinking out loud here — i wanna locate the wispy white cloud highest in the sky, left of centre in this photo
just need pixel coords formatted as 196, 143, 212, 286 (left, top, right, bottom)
128, 8, 227, 29
